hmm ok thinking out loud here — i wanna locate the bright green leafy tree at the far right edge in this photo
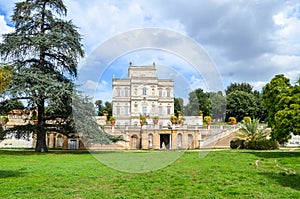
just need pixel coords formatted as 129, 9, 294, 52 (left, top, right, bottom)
264, 75, 300, 144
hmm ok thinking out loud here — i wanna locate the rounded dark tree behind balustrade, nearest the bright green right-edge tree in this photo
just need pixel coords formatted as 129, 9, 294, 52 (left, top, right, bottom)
226, 91, 257, 121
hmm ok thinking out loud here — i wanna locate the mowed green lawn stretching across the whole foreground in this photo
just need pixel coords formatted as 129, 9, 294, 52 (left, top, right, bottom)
0, 149, 300, 199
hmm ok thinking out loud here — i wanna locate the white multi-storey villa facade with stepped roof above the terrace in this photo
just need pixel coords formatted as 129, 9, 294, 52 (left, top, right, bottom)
112, 64, 174, 125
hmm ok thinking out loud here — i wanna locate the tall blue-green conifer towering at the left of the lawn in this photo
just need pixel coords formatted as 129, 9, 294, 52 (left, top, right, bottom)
0, 0, 84, 152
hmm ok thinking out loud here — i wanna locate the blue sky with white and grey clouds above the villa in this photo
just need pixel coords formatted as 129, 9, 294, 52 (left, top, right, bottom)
0, 0, 300, 104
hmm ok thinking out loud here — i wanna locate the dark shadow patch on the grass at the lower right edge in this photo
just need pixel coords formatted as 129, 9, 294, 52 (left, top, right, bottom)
260, 172, 300, 191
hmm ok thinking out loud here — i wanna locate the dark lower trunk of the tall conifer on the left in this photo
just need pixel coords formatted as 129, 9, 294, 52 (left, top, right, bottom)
35, 97, 48, 152
